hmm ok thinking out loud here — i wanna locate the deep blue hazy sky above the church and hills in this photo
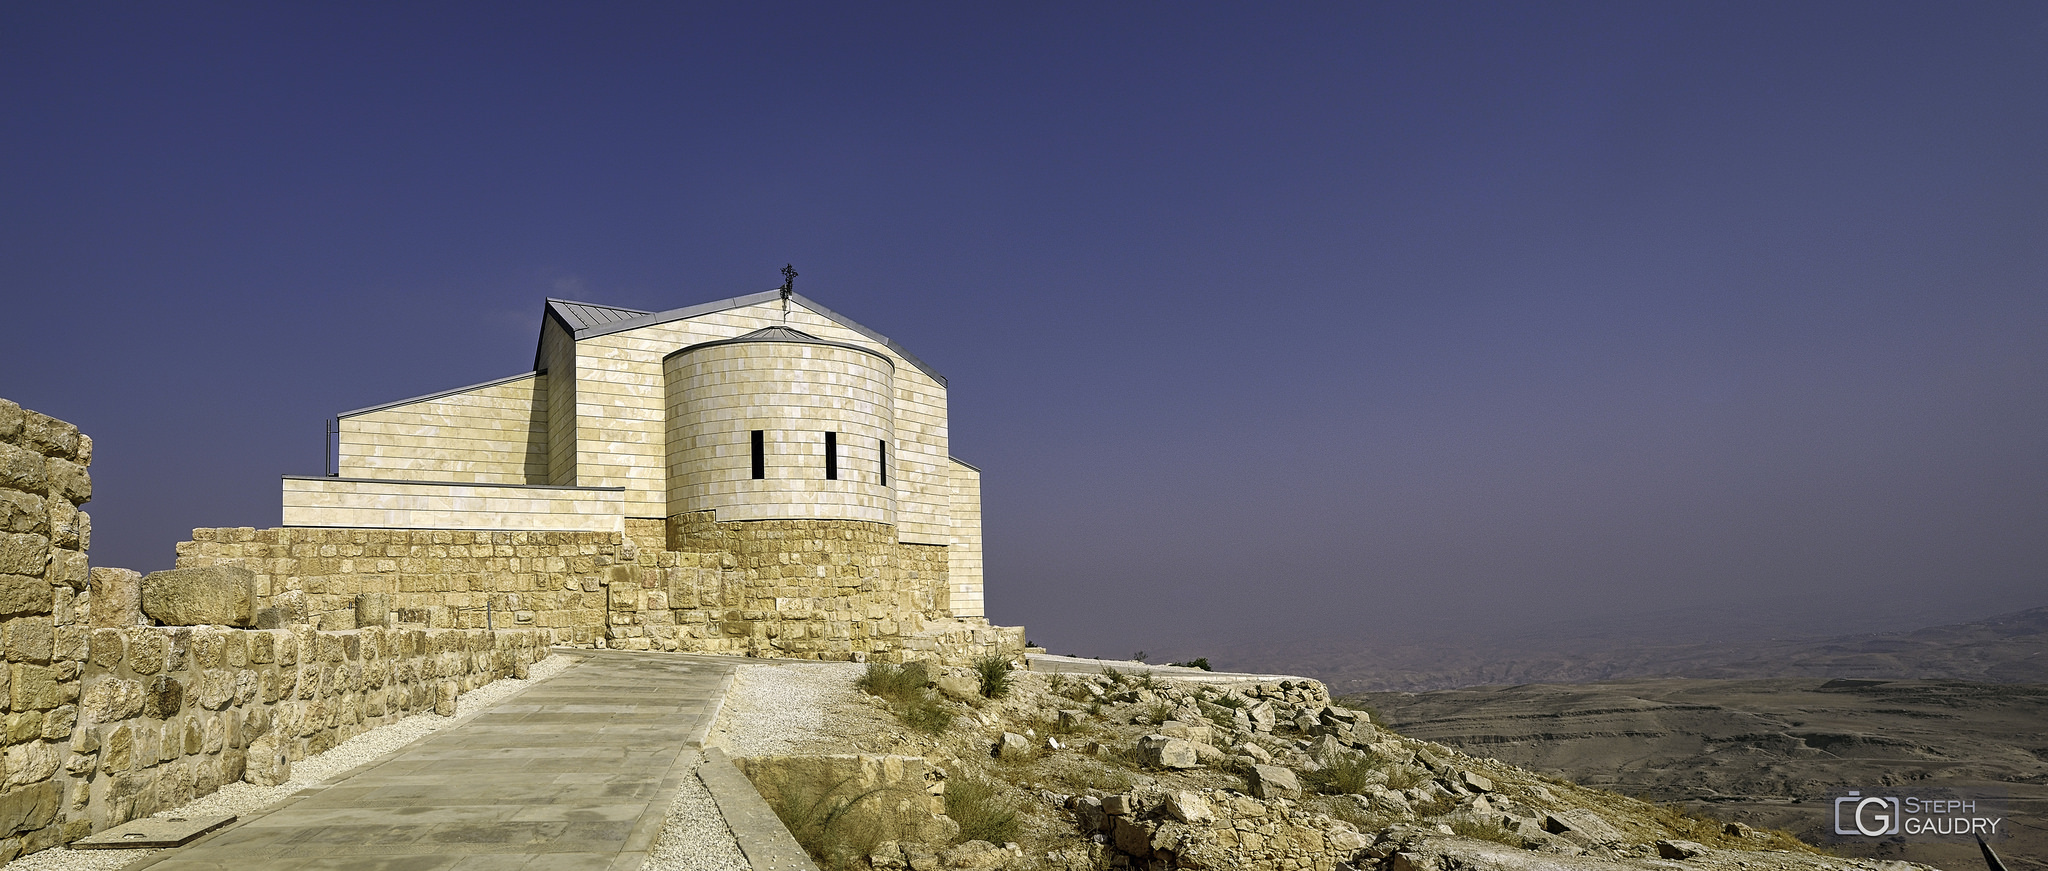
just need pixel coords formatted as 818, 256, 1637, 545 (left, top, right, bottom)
0, 2, 2048, 656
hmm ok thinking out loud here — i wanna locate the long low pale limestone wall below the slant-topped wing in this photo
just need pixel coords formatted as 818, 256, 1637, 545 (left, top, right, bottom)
283, 478, 625, 533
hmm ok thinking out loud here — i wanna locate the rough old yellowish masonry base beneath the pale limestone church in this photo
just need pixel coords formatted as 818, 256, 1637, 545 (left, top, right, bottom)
178, 512, 1024, 662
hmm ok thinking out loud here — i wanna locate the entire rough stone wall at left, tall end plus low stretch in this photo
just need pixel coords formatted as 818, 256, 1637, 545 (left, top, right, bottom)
0, 400, 561, 863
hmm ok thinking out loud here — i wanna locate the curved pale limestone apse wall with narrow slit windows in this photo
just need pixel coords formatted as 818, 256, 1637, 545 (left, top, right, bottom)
664, 342, 895, 523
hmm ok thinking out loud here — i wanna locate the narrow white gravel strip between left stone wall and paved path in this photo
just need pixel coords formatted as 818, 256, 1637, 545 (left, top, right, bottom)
6, 654, 577, 871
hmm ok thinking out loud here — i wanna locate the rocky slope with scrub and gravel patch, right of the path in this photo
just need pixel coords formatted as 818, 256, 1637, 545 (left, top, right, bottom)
723, 666, 1917, 871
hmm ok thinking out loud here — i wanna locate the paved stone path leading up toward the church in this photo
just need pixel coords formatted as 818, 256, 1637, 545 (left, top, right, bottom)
132, 650, 733, 871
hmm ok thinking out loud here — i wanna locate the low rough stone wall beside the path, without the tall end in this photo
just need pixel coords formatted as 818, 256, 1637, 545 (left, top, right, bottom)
66, 625, 549, 827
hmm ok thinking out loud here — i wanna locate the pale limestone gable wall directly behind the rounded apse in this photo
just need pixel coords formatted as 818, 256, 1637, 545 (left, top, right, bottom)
569, 303, 952, 545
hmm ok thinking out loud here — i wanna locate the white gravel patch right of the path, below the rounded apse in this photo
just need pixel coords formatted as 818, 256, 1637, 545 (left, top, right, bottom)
719, 662, 866, 756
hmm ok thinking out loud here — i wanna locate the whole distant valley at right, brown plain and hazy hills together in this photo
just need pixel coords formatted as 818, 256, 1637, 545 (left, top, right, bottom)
1219, 607, 2048, 871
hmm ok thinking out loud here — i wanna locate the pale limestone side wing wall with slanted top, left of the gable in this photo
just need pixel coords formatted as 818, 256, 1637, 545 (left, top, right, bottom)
338, 375, 547, 484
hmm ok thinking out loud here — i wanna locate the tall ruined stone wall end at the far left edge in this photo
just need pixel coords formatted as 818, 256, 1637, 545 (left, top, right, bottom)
0, 400, 92, 863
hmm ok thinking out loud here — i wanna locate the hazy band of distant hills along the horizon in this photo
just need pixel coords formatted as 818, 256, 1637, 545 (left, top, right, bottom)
1210, 607, 2048, 693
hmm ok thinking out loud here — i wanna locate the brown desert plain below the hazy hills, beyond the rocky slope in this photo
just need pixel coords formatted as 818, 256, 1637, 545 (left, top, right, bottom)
1348, 678, 2048, 871
